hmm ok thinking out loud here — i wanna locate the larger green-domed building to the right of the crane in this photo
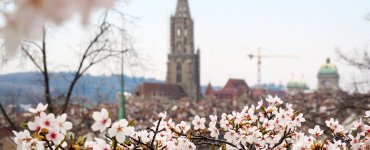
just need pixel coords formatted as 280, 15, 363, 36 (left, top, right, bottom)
317, 58, 340, 93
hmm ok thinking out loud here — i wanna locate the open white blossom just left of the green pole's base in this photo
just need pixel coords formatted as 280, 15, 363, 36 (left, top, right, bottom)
91, 108, 111, 132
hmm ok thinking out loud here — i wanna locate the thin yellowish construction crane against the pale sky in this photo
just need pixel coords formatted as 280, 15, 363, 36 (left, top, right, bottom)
248, 47, 296, 90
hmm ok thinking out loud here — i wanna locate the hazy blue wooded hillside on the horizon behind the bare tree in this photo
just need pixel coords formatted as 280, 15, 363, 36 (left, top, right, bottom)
0, 72, 163, 103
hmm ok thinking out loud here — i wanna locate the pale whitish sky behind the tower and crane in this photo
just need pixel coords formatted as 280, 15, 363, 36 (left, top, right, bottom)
0, 0, 370, 92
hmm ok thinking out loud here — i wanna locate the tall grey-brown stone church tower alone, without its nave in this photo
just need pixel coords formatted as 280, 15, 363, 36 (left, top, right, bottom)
167, 0, 201, 100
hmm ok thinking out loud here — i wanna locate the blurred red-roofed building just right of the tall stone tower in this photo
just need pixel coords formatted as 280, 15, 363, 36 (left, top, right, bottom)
204, 79, 250, 99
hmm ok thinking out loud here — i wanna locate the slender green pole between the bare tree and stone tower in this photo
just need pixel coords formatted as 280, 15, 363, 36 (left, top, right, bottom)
118, 51, 126, 119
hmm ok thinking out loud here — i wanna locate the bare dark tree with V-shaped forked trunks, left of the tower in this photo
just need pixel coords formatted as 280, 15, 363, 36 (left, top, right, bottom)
10, 10, 133, 113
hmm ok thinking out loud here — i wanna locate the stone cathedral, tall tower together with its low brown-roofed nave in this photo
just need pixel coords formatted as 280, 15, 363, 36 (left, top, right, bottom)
135, 0, 201, 100
